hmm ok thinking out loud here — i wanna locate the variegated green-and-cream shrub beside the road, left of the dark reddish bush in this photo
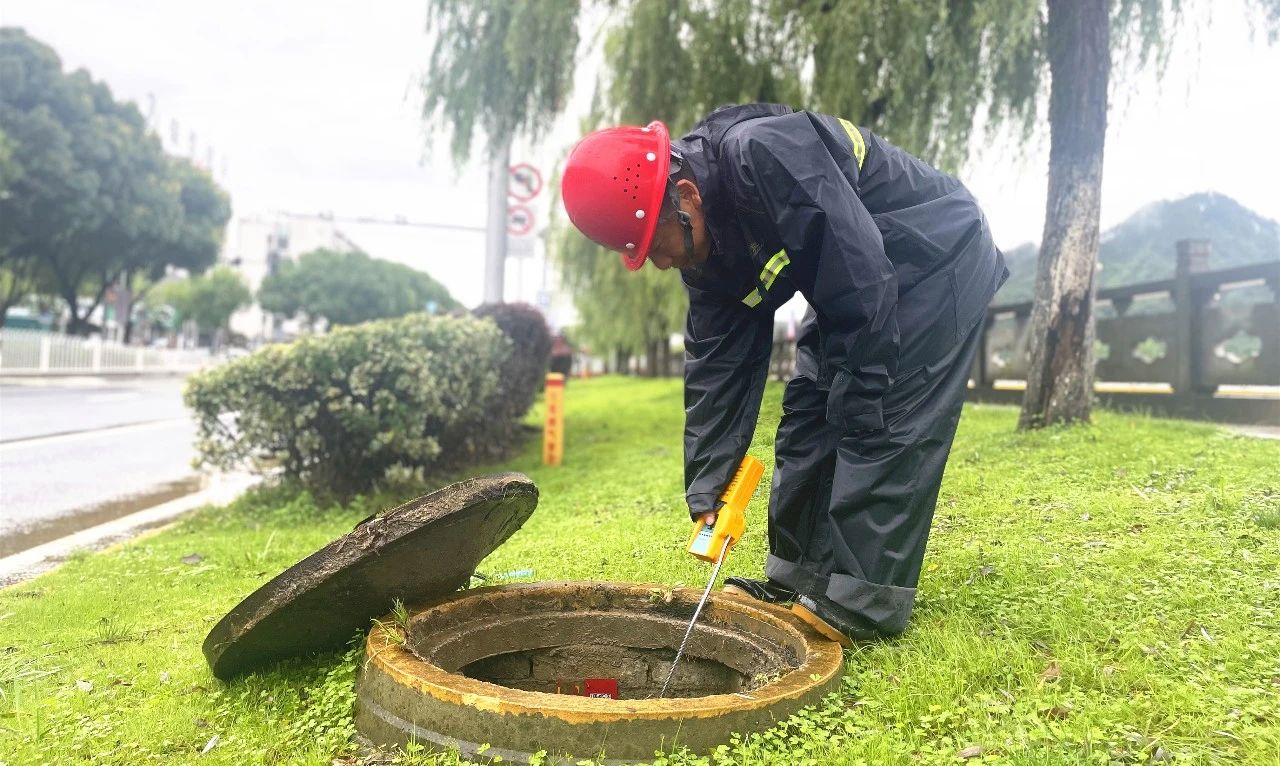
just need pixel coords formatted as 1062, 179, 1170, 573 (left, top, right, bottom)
186, 314, 512, 496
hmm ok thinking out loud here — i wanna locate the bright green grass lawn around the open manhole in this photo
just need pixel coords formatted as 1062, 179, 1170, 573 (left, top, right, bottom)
0, 378, 1280, 766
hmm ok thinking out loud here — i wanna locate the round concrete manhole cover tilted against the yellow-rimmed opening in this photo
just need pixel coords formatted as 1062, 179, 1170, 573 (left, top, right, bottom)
204, 473, 538, 679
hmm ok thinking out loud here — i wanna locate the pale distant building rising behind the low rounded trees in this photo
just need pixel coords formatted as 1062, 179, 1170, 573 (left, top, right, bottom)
219, 214, 360, 346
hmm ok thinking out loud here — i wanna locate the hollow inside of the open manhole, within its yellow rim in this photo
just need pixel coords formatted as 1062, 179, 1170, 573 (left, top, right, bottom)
406, 588, 804, 699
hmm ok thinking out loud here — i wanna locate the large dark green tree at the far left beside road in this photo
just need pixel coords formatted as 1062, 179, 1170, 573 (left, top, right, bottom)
0, 28, 229, 333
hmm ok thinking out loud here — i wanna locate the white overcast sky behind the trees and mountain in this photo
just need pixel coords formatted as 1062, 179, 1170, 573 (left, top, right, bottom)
0, 0, 1280, 302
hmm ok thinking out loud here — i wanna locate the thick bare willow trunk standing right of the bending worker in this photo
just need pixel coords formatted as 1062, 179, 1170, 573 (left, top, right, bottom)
1018, 0, 1111, 429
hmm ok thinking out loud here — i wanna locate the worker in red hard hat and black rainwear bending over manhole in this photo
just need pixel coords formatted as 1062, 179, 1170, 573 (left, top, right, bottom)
562, 104, 1009, 646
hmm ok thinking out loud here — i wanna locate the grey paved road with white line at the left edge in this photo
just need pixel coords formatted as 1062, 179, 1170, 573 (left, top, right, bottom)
0, 378, 195, 556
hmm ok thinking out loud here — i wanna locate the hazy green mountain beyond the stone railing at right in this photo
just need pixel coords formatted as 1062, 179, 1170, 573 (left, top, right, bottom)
995, 193, 1280, 304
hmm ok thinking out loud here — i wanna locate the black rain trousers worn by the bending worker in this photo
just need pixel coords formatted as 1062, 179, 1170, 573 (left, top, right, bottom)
765, 314, 982, 635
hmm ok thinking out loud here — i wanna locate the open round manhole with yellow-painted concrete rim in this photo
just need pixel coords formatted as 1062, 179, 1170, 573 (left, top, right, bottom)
356, 583, 842, 763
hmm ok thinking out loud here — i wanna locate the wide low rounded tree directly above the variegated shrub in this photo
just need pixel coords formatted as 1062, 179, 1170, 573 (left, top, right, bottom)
257, 250, 460, 324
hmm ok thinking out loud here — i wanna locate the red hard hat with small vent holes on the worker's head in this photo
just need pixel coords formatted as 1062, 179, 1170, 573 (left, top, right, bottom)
561, 120, 671, 272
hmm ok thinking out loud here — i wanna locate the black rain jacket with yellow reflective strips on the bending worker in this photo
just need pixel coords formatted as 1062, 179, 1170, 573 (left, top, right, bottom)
672, 104, 1009, 517
